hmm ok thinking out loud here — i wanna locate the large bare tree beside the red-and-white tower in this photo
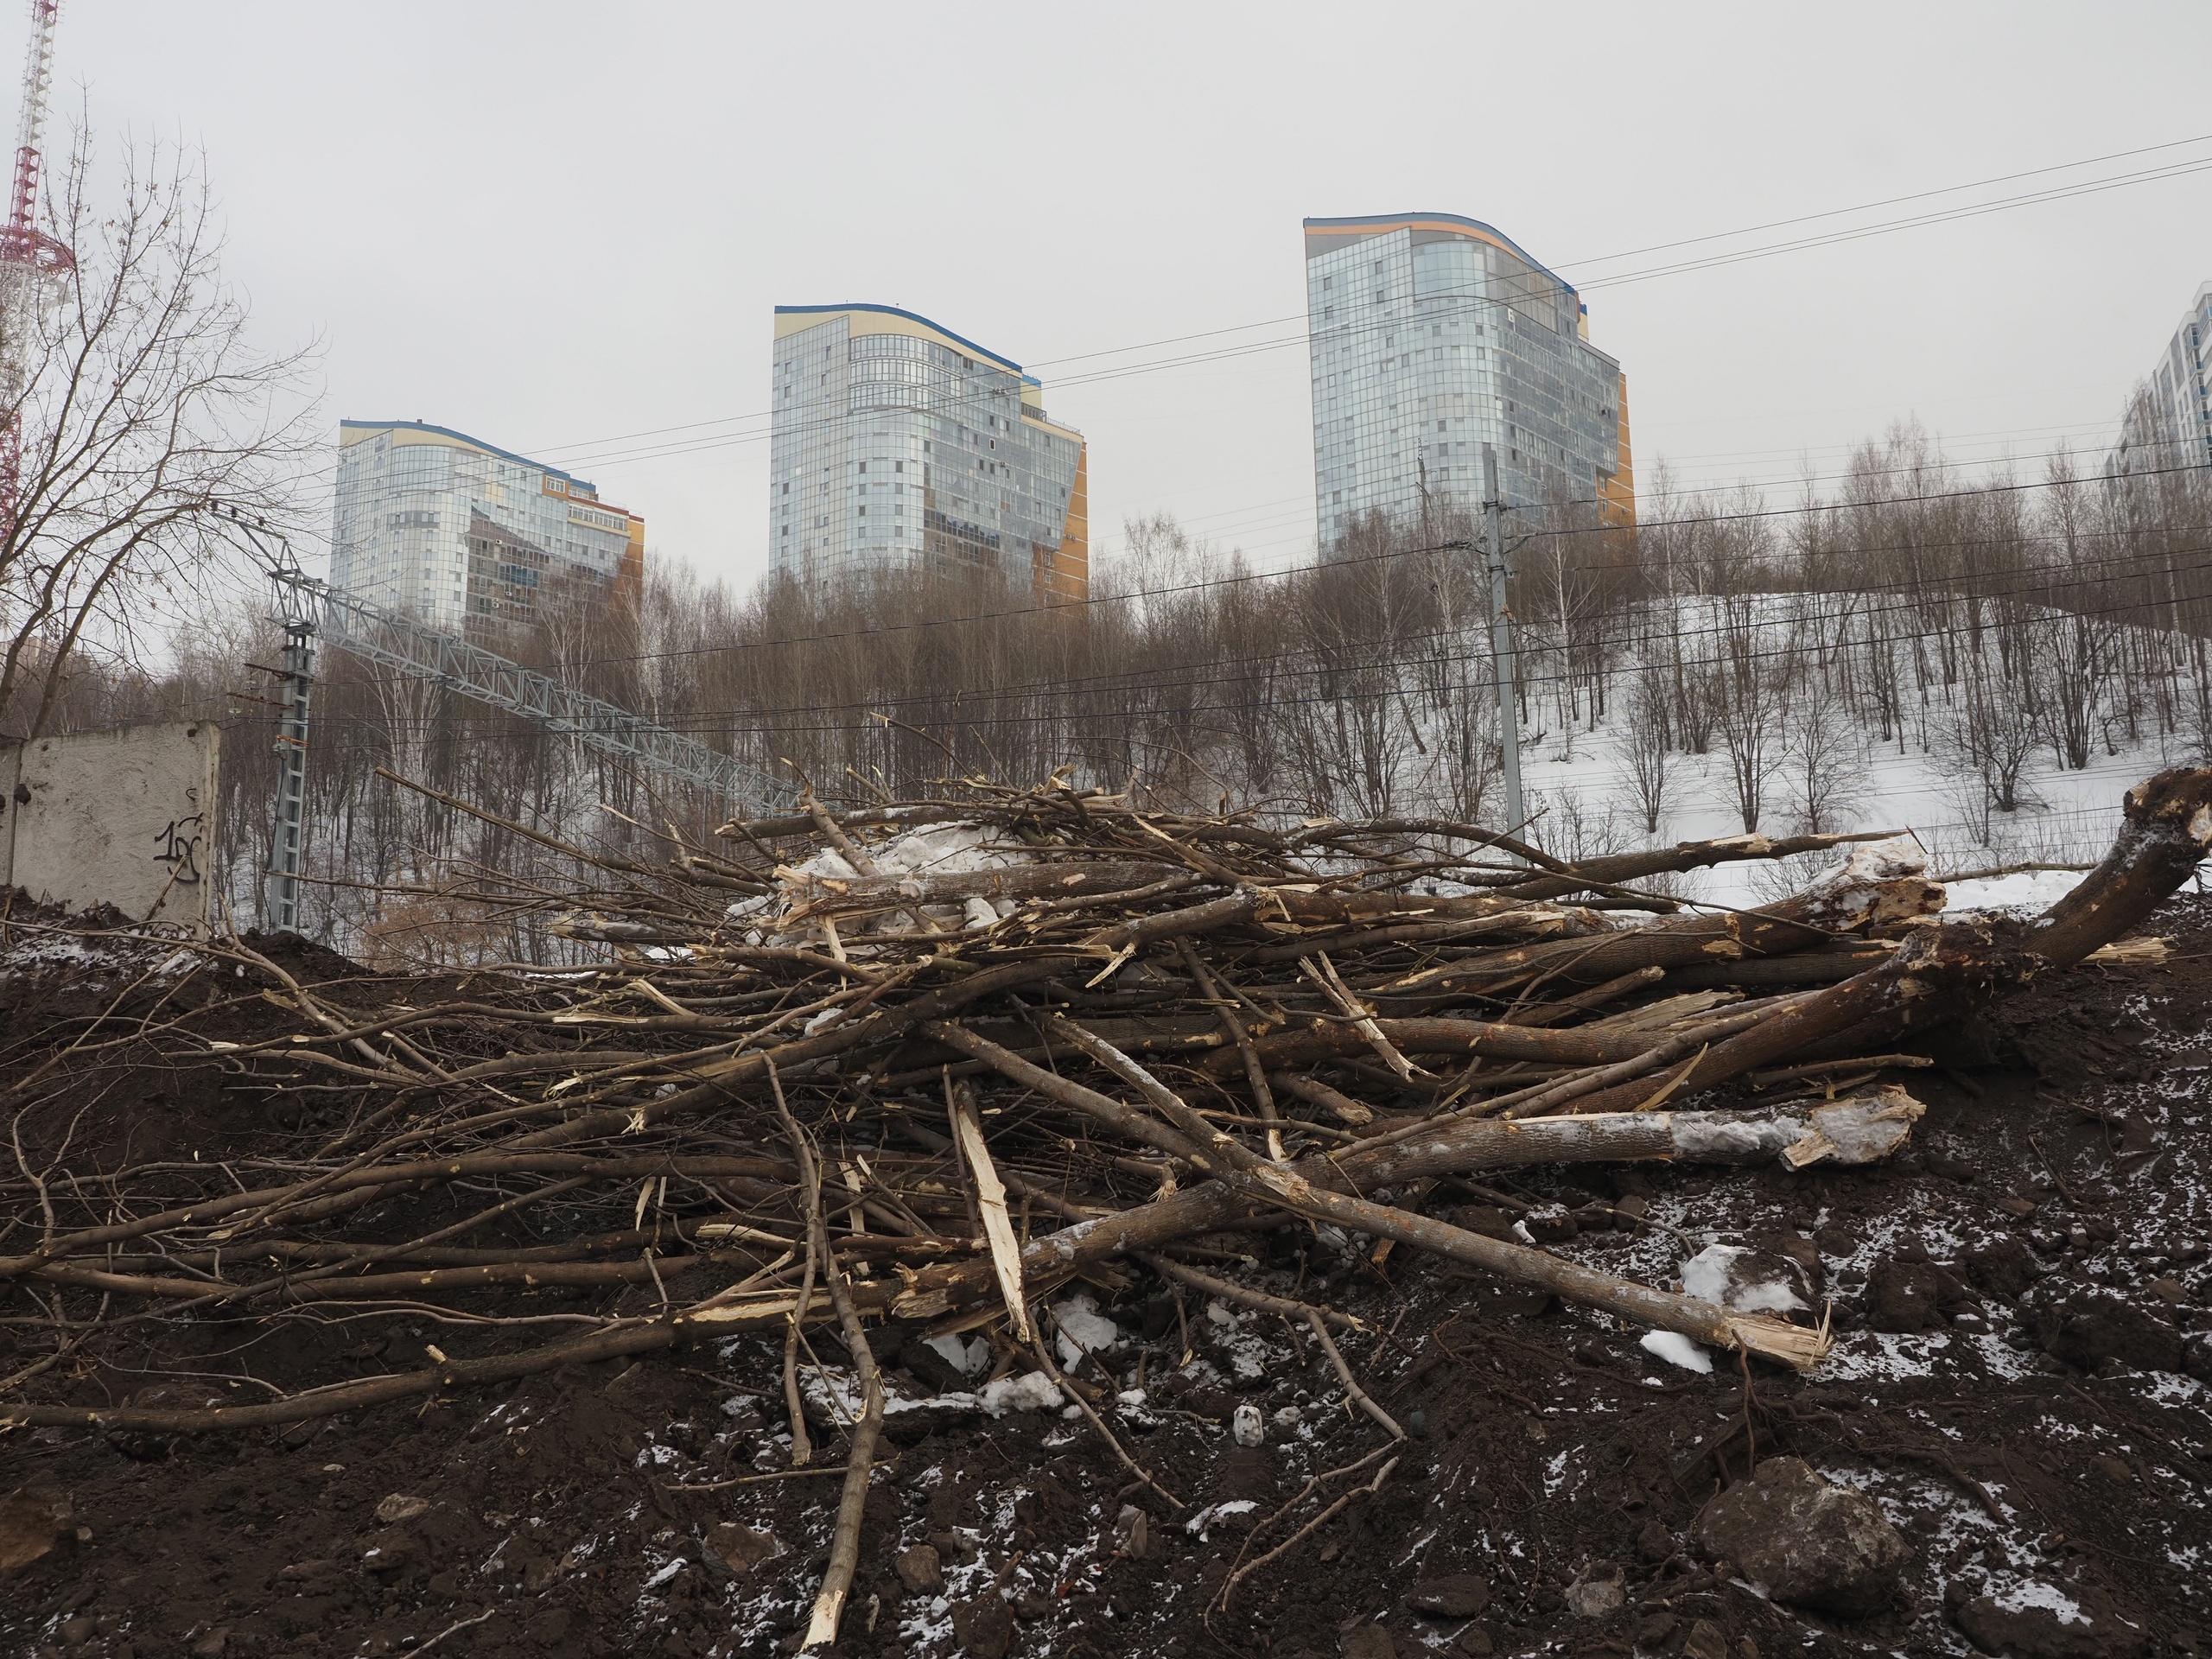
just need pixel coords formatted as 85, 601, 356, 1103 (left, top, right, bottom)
0, 137, 315, 736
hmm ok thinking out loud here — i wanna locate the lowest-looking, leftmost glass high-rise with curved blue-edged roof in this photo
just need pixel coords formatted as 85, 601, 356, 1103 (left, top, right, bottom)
329, 420, 646, 637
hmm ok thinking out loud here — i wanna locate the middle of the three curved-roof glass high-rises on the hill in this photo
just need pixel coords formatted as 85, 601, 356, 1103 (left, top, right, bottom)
767, 305, 1090, 600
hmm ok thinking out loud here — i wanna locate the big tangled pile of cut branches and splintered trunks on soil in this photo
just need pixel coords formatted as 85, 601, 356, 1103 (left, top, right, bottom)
0, 770, 2212, 1637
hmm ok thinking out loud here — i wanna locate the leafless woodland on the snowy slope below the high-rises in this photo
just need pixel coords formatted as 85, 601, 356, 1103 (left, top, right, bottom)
0, 431, 2212, 960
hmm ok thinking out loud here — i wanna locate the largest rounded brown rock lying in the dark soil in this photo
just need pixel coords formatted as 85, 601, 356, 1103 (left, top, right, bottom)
1697, 1458, 1911, 1617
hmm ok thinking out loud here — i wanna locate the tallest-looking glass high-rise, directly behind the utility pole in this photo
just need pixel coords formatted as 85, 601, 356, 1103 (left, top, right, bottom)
1305, 213, 1635, 544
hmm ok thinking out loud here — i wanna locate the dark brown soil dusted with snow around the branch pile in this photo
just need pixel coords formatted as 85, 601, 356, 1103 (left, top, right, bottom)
0, 900, 2212, 1659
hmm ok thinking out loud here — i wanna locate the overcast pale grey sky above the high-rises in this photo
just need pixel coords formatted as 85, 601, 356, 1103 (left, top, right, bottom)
55, 0, 2212, 582
